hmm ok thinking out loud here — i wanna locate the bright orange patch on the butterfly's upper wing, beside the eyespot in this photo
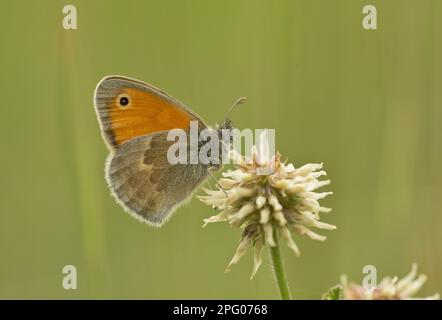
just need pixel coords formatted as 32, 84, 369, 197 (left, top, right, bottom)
108, 88, 191, 146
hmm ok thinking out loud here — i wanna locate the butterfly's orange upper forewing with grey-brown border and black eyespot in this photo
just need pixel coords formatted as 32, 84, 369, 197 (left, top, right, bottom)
94, 76, 206, 149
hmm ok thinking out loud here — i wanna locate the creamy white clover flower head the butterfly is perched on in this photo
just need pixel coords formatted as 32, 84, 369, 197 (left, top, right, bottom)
199, 147, 336, 278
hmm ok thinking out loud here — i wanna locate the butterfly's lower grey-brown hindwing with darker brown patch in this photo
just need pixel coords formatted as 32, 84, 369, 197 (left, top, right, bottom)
106, 131, 208, 225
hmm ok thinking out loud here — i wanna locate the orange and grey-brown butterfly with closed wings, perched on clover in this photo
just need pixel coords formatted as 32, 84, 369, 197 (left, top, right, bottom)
94, 76, 238, 226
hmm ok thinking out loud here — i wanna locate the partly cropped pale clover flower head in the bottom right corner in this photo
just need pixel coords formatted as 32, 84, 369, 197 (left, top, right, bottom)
334, 264, 439, 300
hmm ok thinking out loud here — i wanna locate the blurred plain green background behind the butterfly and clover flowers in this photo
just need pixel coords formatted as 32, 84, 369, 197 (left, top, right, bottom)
0, 0, 442, 299
